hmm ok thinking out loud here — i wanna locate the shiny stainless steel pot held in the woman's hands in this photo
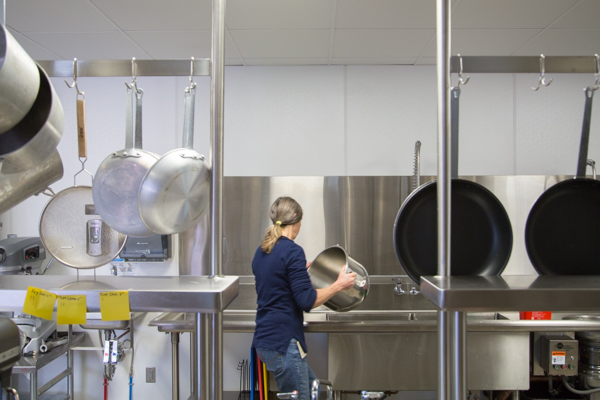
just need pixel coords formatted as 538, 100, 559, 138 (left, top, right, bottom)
308, 246, 369, 311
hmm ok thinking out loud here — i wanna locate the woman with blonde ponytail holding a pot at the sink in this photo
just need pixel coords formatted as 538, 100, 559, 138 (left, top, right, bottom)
252, 197, 356, 400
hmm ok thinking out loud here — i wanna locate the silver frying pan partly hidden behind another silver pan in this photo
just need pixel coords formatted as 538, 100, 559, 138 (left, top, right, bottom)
92, 85, 159, 237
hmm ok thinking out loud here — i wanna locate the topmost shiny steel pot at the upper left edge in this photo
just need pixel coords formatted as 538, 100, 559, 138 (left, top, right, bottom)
0, 24, 40, 134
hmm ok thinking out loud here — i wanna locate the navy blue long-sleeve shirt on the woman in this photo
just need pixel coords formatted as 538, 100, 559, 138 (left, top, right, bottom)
252, 236, 317, 354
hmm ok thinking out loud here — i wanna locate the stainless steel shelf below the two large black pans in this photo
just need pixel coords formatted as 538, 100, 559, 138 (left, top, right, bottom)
421, 275, 600, 311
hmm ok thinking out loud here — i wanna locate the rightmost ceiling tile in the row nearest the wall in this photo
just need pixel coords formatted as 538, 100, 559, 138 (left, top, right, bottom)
515, 29, 600, 56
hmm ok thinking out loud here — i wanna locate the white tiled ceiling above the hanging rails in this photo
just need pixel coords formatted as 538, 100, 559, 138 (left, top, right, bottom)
6, 0, 600, 65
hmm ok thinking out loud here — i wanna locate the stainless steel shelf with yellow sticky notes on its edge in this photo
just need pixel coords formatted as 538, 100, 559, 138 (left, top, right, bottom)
0, 275, 239, 313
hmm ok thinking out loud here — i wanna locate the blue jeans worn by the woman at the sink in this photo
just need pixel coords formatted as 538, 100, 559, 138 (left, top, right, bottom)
256, 339, 317, 400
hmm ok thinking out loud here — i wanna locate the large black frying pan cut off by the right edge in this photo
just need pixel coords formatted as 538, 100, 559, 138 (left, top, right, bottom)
525, 87, 600, 275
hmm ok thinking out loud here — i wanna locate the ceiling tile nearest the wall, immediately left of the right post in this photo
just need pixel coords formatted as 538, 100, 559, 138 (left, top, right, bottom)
333, 29, 435, 58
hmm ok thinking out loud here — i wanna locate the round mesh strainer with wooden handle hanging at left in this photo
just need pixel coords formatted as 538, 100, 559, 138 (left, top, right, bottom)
40, 92, 127, 268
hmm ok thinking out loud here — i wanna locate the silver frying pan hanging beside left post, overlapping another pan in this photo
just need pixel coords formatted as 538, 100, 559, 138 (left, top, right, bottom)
139, 82, 210, 235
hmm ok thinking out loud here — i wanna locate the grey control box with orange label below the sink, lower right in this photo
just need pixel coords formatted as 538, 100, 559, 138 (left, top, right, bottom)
540, 336, 579, 376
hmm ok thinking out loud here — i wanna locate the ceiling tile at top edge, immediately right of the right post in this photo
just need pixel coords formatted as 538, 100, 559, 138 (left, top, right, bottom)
452, 0, 578, 29
